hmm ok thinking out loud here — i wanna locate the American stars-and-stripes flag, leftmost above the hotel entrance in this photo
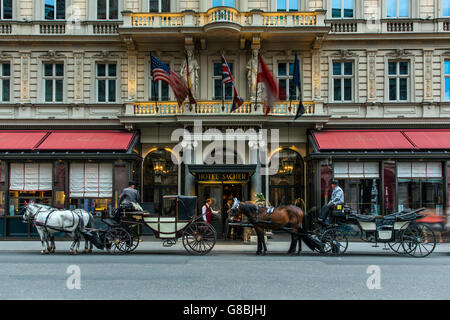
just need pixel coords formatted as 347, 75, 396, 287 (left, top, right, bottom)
150, 55, 189, 106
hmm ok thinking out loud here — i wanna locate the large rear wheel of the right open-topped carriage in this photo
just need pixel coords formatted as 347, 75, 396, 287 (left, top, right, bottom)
402, 224, 436, 258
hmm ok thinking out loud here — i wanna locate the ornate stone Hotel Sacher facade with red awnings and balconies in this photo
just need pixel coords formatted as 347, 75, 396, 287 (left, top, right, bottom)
0, 0, 450, 239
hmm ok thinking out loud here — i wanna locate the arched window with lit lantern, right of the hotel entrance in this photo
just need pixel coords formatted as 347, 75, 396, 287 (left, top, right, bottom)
269, 149, 304, 209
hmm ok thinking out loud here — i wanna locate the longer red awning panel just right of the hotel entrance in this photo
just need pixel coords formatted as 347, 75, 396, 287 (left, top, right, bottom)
313, 130, 414, 150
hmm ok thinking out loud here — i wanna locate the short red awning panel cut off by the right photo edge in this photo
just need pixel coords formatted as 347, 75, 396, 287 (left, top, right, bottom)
404, 130, 450, 150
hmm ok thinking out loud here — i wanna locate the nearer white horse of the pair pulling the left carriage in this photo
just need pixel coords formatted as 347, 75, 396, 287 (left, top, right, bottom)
23, 202, 92, 254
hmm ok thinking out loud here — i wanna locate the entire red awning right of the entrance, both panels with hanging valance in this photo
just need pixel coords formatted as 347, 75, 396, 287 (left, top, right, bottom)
310, 129, 450, 157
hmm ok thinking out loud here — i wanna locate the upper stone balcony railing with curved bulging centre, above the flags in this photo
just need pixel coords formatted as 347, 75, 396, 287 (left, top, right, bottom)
123, 7, 325, 28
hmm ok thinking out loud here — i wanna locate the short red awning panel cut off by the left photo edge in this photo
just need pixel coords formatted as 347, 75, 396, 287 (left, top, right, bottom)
0, 130, 48, 150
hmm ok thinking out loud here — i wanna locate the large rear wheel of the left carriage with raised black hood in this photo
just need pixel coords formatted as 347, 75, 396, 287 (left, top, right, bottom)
182, 221, 217, 255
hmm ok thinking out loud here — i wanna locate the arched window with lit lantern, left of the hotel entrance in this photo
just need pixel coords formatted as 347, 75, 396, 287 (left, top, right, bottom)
142, 149, 178, 213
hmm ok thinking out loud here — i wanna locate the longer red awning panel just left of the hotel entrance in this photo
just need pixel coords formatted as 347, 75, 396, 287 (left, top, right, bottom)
36, 130, 134, 150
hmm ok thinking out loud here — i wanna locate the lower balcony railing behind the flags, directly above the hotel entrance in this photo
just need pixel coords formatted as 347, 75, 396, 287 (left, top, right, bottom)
134, 101, 315, 116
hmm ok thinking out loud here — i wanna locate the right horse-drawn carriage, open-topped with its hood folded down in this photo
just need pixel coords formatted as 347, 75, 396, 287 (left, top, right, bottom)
313, 206, 436, 257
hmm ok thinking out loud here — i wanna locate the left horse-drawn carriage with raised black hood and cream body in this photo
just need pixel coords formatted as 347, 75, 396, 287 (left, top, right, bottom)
87, 195, 217, 255
